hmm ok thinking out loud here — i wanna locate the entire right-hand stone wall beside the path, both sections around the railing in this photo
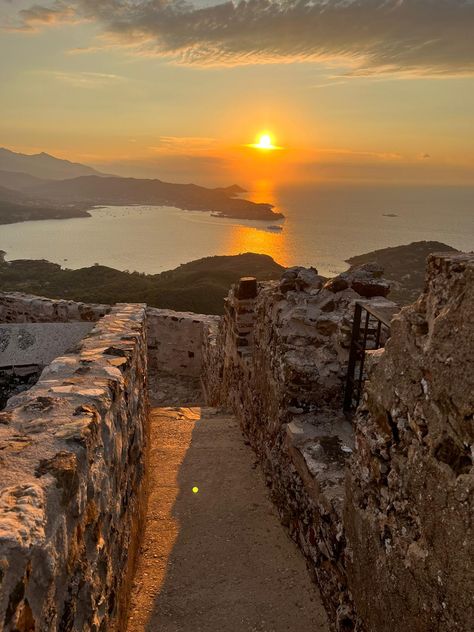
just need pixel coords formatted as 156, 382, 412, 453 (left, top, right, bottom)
203, 255, 474, 632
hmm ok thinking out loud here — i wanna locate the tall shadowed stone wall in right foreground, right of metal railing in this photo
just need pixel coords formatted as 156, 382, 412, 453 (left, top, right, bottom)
345, 254, 474, 632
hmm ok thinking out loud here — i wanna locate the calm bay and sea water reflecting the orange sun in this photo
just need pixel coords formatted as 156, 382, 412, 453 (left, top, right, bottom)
0, 183, 474, 275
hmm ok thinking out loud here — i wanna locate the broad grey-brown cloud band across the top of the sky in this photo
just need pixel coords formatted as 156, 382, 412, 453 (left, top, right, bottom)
3, 0, 474, 76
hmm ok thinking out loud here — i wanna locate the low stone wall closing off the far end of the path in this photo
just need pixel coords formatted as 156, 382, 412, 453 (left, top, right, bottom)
147, 307, 219, 377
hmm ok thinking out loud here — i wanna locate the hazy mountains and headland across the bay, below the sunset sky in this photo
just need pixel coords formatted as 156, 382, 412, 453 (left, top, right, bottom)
0, 149, 284, 224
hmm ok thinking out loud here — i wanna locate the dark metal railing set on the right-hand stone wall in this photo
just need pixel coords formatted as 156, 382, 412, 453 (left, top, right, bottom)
344, 301, 400, 413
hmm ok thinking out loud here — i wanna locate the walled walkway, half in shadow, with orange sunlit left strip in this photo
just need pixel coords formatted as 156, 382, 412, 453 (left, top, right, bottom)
127, 408, 328, 632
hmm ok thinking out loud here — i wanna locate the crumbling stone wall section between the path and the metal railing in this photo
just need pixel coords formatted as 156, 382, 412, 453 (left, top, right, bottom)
203, 269, 387, 630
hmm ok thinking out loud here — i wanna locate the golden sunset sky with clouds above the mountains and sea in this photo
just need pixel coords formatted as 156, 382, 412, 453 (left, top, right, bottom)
0, 0, 474, 185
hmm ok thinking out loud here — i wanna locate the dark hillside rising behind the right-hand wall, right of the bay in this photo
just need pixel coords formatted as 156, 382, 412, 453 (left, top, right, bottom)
347, 241, 456, 305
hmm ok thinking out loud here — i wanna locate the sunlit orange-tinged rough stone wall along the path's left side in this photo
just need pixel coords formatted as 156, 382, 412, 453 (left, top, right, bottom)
0, 305, 147, 632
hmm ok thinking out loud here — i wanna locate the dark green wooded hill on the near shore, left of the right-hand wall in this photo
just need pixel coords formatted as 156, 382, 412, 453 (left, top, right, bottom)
0, 253, 284, 314
